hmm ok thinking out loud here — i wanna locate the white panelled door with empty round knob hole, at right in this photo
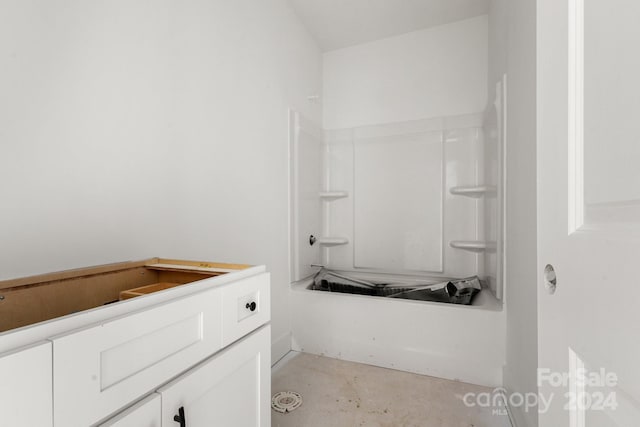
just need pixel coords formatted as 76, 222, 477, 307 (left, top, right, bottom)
537, 0, 640, 427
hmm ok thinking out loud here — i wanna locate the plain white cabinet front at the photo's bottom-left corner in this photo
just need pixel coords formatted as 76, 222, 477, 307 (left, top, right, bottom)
0, 342, 53, 427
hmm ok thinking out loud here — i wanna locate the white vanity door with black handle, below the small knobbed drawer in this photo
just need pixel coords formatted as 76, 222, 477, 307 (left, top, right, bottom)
158, 325, 271, 427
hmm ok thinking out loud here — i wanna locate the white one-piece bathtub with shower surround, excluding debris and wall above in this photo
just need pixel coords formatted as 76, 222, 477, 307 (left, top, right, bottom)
290, 75, 505, 386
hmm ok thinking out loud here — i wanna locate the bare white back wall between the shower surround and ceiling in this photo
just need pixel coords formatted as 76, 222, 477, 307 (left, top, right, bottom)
323, 16, 488, 129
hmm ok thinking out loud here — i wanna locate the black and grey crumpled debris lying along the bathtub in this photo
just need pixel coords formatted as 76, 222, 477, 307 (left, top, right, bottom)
311, 268, 482, 305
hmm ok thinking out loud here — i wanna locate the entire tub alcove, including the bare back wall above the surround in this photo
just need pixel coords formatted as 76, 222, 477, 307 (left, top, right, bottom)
289, 11, 507, 387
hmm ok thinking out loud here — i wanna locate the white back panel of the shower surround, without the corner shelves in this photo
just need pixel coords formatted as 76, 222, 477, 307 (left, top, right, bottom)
323, 114, 484, 277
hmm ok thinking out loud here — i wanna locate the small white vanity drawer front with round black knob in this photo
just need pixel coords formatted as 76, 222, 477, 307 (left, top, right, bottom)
222, 273, 271, 347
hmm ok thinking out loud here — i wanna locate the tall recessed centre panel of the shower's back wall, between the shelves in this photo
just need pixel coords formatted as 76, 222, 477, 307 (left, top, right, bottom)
353, 132, 443, 272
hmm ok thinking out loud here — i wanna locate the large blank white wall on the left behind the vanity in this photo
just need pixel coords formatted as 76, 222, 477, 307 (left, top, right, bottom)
0, 0, 321, 364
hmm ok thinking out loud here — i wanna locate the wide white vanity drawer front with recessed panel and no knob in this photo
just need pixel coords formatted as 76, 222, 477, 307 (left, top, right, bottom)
52, 289, 222, 427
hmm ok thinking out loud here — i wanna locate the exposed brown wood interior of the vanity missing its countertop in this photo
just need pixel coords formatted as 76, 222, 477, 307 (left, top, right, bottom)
0, 258, 250, 332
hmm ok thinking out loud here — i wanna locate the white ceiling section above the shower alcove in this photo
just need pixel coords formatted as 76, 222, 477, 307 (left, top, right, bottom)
289, 0, 489, 51
